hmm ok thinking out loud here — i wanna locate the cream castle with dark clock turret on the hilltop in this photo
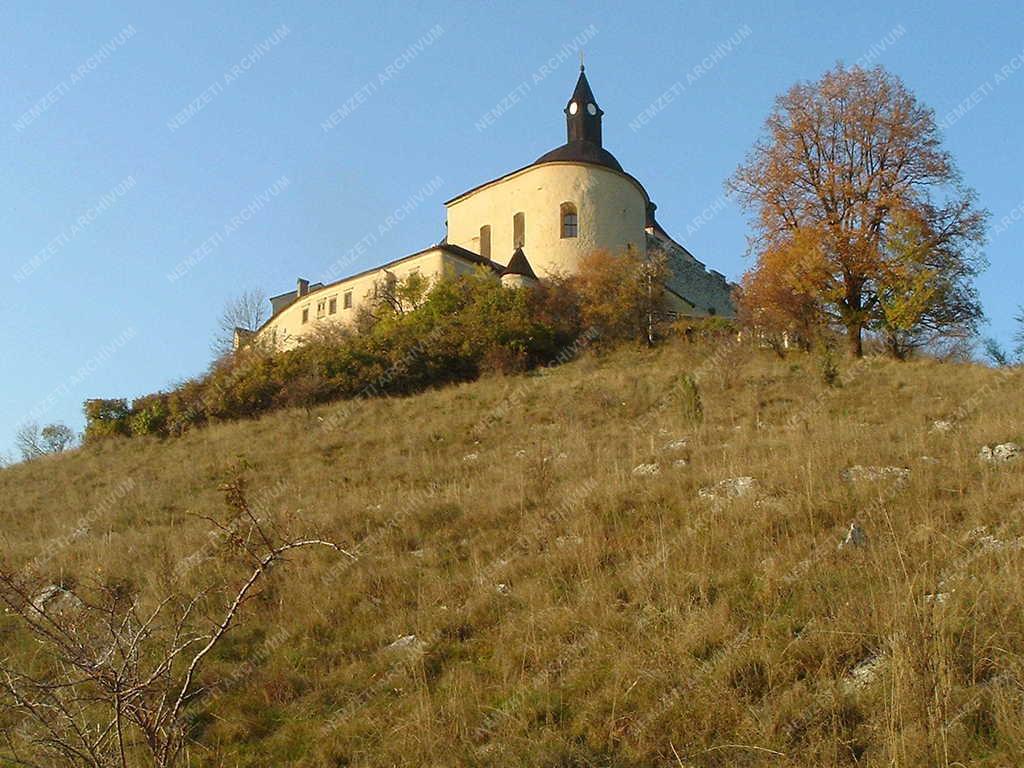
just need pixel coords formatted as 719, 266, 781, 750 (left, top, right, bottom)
256, 66, 734, 348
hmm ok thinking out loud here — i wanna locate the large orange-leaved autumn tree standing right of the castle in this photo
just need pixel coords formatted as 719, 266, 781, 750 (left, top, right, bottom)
727, 66, 987, 356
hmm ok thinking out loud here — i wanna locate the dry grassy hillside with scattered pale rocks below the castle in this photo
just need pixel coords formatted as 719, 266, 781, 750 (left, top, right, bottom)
0, 342, 1024, 767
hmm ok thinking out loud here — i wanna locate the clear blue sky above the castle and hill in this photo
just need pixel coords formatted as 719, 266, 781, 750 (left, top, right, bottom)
0, 0, 1024, 453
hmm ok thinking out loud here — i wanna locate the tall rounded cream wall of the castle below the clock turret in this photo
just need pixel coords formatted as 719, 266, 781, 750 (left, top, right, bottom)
447, 163, 647, 278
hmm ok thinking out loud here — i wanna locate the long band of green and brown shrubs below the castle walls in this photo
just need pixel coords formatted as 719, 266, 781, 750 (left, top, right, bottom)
79, 270, 699, 441
